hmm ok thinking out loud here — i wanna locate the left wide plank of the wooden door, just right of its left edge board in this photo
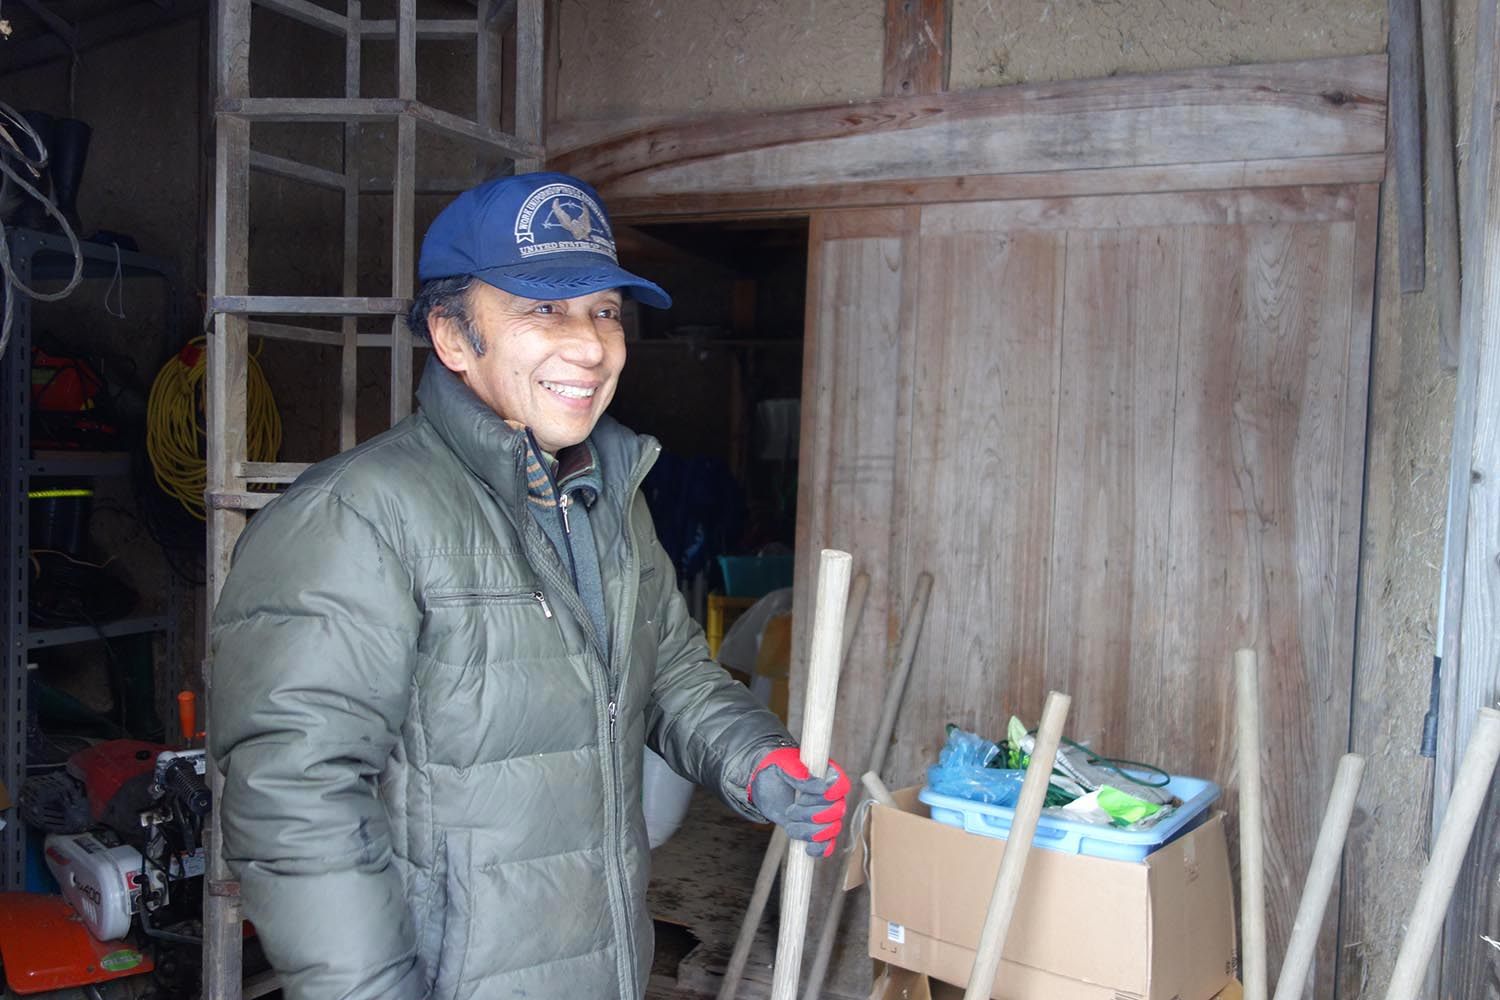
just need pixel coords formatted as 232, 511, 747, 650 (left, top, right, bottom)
890, 223, 1065, 784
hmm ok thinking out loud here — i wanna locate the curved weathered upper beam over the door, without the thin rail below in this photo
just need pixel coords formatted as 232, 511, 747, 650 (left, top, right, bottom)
551, 55, 1386, 207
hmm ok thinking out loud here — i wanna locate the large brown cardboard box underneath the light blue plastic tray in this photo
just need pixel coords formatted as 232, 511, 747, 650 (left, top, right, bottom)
849, 789, 1236, 1000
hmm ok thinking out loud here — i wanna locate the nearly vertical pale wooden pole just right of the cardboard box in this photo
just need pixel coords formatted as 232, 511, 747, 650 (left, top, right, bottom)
1235, 649, 1266, 1000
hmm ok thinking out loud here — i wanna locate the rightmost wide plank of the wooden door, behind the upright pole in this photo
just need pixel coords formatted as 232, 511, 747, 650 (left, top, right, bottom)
1163, 220, 1368, 996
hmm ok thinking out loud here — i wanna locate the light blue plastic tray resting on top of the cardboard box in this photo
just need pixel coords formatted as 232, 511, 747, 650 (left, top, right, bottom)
917, 774, 1220, 861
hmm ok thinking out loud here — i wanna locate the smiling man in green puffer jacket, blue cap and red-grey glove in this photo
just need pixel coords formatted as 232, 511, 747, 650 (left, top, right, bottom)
210, 174, 848, 1000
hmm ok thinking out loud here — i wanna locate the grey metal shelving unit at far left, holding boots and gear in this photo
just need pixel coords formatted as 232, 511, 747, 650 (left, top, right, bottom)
0, 229, 179, 891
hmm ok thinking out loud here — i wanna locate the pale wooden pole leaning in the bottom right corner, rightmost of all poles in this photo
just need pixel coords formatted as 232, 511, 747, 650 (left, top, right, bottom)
1386, 708, 1500, 1000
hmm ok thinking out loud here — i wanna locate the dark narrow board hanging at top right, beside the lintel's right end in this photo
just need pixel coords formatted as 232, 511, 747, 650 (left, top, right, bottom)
1388, 0, 1427, 292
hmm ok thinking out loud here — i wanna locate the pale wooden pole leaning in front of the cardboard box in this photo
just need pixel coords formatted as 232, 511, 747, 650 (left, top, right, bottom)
963, 691, 1073, 1000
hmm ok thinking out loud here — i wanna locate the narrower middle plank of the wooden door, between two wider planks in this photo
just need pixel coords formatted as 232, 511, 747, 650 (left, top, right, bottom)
1047, 228, 1182, 759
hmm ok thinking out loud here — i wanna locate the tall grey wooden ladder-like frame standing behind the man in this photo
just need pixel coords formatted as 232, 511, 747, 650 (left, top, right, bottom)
203, 0, 543, 1000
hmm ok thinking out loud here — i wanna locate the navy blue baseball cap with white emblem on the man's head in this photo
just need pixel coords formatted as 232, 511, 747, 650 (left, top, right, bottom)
417, 174, 672, 309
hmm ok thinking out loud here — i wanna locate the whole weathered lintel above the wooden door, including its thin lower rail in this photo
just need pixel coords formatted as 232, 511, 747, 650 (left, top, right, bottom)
548, 54, 1386, 222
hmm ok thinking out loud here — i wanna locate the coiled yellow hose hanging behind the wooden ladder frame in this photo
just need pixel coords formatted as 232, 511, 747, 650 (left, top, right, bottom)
146, 337, 281, 520
